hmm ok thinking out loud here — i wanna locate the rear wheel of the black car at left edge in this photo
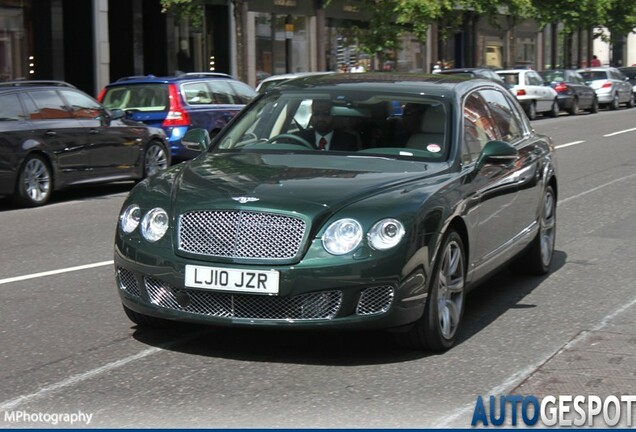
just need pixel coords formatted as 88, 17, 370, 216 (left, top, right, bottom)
13, 155, 53, 207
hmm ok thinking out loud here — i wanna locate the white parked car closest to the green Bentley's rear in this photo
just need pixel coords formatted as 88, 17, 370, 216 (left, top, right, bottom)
496, 69, 560, 120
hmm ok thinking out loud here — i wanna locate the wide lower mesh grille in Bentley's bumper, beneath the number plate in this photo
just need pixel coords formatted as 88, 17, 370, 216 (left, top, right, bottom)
145, 277, 342, 320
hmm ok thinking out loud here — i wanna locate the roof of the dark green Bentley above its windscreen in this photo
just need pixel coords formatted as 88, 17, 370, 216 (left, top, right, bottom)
273, 72, 486, 97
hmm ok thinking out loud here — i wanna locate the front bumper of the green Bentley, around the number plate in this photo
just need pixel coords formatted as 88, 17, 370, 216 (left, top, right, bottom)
115, 247, 427, 329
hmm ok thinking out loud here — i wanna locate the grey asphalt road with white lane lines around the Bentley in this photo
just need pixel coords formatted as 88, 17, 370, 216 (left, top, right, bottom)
0, 109, 636, 428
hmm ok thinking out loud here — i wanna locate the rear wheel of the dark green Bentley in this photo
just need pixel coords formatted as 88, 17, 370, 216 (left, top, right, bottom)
515, 186, 556, 276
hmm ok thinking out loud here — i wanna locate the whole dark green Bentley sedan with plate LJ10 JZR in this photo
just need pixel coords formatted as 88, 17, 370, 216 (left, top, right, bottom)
115, 73, 558, 351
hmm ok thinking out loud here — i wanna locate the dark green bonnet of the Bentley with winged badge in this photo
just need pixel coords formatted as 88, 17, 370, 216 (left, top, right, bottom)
172, 153, 448, 218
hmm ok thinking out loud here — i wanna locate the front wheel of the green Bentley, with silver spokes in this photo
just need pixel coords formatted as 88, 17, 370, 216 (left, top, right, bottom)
396, 231, 466, 351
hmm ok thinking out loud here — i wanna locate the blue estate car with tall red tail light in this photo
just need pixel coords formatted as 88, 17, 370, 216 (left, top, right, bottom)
99, 72, 257, 162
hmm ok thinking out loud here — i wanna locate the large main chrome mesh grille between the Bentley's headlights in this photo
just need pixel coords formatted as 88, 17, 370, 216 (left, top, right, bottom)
179, 211, 306, 260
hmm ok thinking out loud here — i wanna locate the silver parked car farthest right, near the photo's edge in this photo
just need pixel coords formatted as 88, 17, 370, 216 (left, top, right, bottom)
579, 67, 634, 110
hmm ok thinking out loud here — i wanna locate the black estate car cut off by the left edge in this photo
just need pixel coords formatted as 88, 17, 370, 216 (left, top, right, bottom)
0, 81, 170, 207
